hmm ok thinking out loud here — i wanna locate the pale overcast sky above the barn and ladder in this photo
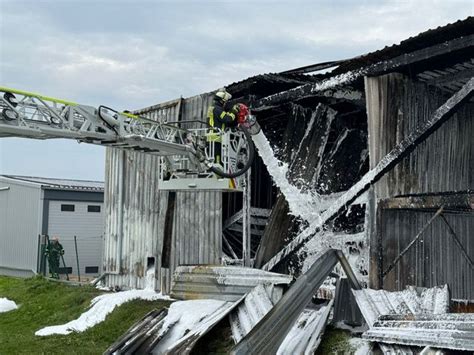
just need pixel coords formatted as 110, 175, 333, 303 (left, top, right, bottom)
0, 0, 468, 180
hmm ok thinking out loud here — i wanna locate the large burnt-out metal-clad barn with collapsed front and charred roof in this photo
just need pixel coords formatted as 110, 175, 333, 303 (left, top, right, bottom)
103, 18, 474, 299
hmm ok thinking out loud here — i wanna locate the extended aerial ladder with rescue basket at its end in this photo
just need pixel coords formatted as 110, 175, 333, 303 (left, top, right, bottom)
0, 87, 260, 191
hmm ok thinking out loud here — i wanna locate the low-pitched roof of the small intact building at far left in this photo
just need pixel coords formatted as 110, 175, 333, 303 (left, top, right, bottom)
0, 175, 104, 192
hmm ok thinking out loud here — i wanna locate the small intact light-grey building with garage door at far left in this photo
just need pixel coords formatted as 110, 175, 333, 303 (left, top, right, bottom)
0, 175, 104, 277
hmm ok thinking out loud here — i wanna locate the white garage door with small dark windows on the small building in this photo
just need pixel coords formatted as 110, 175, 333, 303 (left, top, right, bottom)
48, 201, 104, 276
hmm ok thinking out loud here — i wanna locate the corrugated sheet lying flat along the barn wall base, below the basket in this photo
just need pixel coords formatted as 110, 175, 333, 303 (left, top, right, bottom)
171, 265, 293, 301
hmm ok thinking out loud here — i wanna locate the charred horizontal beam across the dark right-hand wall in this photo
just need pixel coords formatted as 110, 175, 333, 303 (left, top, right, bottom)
379, 192, 474, 210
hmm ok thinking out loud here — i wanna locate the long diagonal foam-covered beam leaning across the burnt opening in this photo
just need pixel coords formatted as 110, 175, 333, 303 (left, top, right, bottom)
262, 78, 474, 270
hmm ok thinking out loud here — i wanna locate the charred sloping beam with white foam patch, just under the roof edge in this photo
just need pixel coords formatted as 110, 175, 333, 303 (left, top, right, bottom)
252, 35, 474, 112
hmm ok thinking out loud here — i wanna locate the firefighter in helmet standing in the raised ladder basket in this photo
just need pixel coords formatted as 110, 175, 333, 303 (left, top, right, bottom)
207, 89, 239, 164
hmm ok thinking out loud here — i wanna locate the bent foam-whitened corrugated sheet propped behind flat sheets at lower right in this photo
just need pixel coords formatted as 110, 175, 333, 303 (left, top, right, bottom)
352, 285, 449, 327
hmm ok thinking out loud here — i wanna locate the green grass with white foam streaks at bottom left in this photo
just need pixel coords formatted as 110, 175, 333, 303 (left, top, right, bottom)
0, 276, 169, 355
